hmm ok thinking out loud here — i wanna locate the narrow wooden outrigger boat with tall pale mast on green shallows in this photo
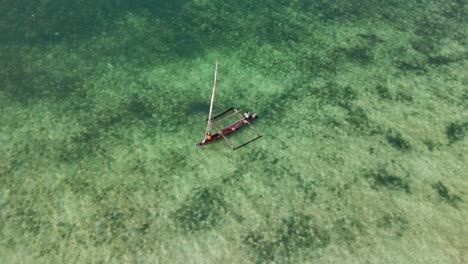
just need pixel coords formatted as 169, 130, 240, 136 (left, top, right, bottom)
197, 60, 262, 150
